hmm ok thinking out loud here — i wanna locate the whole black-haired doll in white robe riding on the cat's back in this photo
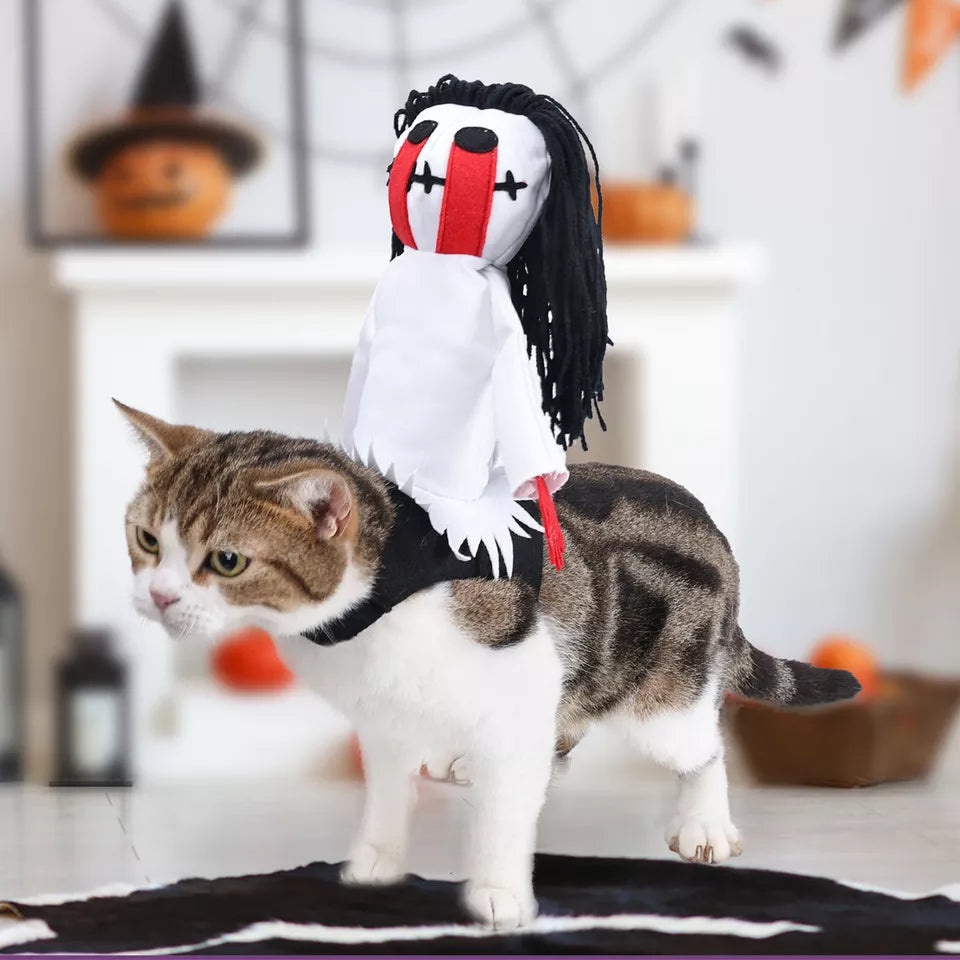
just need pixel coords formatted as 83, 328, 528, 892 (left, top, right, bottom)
344, 76, 608, 576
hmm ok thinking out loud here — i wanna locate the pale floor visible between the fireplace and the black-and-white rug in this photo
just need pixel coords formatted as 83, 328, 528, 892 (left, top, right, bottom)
0, 744, 960, 899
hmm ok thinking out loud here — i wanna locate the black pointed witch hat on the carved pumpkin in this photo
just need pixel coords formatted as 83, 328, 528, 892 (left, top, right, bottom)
69, 0, 262, 180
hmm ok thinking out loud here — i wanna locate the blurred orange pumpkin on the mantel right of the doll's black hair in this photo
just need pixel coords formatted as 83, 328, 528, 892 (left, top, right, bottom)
603, 183, 693, 243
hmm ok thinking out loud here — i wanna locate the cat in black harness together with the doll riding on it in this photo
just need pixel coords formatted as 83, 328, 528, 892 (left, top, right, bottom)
119, 77, 859, 932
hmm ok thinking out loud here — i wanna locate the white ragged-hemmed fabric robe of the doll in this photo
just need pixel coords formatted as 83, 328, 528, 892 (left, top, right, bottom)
344, 249, 568, 576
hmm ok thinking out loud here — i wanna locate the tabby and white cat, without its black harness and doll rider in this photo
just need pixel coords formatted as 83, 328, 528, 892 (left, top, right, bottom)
118, 404, 859, 928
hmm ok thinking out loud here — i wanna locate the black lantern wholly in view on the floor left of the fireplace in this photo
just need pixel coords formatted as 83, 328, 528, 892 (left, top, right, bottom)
51, 630, 131, 787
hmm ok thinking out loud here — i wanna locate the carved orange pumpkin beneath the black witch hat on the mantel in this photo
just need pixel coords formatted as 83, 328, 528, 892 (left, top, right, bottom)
97, 140, 232, 239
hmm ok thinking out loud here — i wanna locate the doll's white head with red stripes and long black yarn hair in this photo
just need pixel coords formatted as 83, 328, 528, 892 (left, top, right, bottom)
388, 75, 607, 449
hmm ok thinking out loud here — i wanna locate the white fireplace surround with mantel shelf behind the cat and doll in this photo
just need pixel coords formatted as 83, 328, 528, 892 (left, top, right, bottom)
55, 246, 762, 780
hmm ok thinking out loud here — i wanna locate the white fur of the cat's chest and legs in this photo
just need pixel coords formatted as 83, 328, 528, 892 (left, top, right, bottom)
272, 584, 740, 929
